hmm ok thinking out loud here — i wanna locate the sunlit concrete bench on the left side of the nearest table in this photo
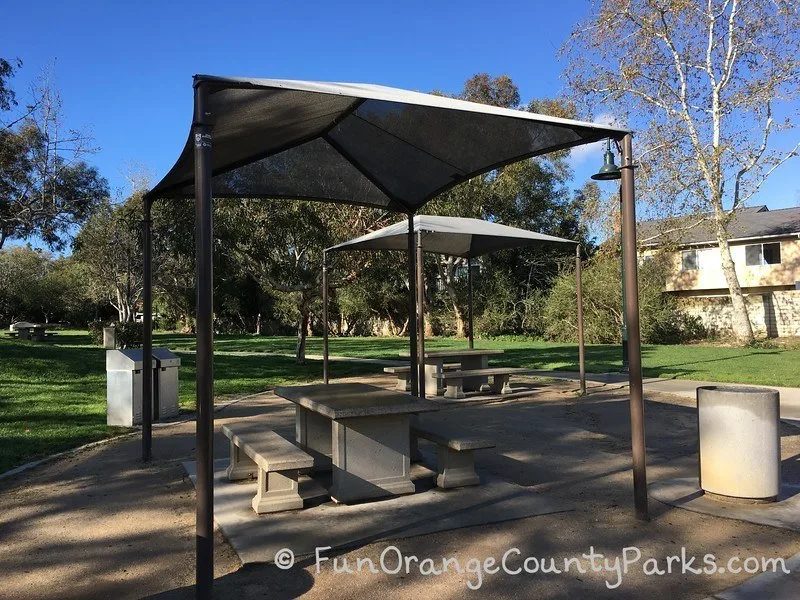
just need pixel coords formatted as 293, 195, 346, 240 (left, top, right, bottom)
222, 420, 314, 514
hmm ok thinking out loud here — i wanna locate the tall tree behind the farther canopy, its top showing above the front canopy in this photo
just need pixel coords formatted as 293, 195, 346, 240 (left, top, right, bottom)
425, 73, 585, 337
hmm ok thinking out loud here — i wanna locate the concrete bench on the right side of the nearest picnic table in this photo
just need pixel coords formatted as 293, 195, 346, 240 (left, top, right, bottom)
411, 419, 496, 488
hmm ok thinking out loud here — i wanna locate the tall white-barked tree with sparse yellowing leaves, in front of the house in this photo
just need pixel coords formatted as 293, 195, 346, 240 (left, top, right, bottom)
562, 0, 800, 343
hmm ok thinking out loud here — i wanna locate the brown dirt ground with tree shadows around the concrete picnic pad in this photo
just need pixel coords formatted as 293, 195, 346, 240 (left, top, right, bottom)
0, 377, 800, 600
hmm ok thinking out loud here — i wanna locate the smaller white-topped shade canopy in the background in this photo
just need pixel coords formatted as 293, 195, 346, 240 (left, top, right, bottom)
326, 215, 577, 258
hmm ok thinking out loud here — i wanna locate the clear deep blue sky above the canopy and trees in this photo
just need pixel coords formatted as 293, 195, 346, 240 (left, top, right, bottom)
0, 0, 800, 214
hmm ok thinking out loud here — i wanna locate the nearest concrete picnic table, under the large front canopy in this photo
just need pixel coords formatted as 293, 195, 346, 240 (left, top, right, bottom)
275, 383, 439, 502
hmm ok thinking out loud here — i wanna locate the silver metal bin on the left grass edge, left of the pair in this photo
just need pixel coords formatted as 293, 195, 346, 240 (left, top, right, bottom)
106, 350, 155, 427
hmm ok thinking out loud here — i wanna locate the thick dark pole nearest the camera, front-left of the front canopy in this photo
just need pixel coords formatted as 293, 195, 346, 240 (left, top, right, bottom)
192, 82, 214, 599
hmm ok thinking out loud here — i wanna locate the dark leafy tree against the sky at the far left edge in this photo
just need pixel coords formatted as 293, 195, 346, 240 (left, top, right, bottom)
0, 59, 108, 250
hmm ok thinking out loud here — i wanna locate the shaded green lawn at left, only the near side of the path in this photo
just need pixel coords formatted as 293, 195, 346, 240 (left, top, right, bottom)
0, 331, 375, 473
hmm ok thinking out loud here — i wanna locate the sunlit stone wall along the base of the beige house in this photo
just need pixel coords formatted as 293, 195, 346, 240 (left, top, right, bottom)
678, 290, 800, 337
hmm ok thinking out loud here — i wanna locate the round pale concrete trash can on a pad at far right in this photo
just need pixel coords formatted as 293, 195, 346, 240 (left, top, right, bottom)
697, 386, 781, 502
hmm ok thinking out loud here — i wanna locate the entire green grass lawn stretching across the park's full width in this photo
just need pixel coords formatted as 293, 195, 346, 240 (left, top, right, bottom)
0, 331, 800, 472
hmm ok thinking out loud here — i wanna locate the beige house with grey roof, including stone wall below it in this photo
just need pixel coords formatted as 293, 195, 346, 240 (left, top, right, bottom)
637, 206, 800, 337
